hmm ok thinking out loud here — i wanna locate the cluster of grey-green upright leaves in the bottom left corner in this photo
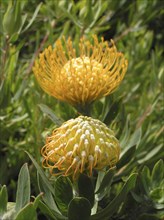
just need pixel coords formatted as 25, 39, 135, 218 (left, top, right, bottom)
0, 164, 41, 220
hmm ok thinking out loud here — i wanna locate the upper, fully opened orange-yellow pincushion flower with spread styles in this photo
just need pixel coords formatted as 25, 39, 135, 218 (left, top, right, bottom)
33, 36, 127, 106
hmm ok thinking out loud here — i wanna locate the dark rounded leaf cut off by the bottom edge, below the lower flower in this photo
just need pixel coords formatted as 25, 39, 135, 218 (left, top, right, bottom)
68, 197, 91, 220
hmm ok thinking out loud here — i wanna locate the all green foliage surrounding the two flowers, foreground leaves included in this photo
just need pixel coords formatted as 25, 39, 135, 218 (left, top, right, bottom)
0, 0, 164, 220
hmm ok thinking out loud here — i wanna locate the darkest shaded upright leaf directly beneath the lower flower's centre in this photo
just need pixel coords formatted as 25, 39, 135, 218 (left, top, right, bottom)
78, 174, 94, 207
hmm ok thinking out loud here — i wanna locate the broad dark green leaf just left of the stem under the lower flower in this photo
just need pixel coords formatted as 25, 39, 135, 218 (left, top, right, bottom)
55, 176, 73, 216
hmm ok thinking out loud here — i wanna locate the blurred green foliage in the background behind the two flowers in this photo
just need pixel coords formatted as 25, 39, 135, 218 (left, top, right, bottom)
0, 0, 164, 219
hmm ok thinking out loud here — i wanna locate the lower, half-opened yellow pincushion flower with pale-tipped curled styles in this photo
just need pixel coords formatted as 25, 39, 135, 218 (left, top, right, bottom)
41, 116, 120, 179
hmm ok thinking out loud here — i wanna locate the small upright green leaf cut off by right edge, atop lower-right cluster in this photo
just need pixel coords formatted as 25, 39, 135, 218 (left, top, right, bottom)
151, 160, 164, 187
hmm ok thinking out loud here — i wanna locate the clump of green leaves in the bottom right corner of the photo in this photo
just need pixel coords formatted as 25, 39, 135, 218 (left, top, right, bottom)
120, 160, 164, 219
